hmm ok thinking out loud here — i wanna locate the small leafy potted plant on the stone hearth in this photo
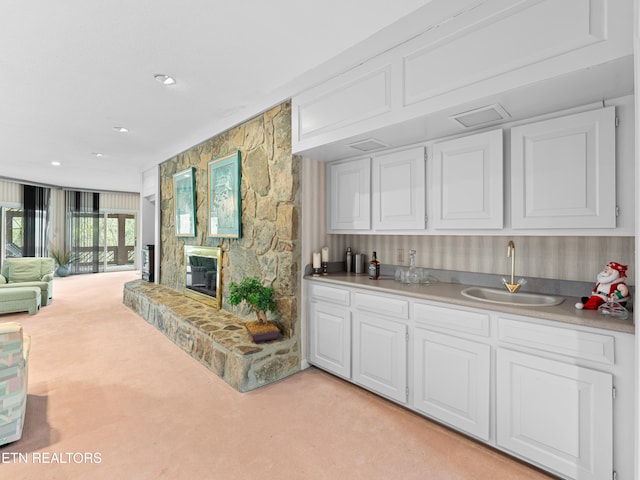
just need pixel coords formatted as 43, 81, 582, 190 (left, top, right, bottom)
228, 277, 280, 343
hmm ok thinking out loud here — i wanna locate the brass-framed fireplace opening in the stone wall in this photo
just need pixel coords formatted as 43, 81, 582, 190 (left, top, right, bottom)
184, 245, 222, 308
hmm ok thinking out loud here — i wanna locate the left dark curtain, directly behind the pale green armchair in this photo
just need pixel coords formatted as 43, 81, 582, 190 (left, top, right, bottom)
22, 185, 51, 257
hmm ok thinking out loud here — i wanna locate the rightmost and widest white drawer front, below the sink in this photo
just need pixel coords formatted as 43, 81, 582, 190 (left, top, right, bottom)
498, 318, 615, 365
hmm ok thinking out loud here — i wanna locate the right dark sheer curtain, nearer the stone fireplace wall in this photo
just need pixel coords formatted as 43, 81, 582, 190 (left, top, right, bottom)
65, 190, 104, 273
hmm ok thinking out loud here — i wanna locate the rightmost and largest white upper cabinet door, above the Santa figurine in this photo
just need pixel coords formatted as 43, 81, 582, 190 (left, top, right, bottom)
511, 107, 616, 228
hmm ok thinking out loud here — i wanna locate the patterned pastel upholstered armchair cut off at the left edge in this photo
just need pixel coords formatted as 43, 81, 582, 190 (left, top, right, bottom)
0, 322, 31, 445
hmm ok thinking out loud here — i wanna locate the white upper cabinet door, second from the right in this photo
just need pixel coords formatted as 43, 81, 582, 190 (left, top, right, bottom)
431, 130, 503, 228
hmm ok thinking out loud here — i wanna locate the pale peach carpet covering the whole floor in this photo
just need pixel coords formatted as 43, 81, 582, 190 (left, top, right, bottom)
0, 272, 550, 480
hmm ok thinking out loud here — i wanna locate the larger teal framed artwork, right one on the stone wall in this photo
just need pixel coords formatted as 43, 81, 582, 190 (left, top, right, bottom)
207, 150, 242, 238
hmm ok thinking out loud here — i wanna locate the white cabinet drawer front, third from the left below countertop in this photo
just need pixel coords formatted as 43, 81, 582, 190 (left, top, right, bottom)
413, 302, 489, 337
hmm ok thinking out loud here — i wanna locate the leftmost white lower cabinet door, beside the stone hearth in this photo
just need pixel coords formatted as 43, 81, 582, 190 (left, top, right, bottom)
309, 303, 351, 378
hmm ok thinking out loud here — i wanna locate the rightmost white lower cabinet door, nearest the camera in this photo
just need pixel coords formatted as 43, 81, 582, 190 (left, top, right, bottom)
497, 348, 613, 480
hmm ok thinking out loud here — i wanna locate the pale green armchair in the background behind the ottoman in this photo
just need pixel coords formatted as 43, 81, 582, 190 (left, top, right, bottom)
0, 257, 55, 306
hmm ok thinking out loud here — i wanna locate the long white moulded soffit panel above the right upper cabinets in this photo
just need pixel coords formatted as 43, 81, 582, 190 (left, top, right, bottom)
404, 0, 607, 105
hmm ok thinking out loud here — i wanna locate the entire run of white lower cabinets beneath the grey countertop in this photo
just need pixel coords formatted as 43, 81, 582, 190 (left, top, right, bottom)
308, 281, 636, 480
